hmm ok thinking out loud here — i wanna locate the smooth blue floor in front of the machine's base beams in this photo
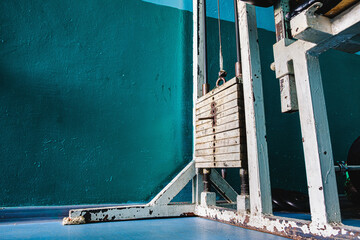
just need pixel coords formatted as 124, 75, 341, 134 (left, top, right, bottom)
0, 217, 285, 240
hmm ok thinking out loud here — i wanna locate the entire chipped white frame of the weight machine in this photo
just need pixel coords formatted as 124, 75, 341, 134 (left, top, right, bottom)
69, 0, 360, 239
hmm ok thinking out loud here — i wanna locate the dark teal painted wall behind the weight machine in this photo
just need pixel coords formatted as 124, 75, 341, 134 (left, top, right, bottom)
0, 0, 360, 206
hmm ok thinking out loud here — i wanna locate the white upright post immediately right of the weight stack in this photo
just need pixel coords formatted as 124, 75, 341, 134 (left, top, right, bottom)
238, 0, 272, 215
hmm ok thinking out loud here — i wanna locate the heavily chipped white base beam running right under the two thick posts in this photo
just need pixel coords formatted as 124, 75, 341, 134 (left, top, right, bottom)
195, 205, 360, 239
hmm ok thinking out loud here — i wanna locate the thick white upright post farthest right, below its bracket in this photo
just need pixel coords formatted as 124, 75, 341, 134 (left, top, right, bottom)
294, 45, 341, 225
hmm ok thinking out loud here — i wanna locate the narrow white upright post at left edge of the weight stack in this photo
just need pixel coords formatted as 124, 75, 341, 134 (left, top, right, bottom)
192, 0, 205, 203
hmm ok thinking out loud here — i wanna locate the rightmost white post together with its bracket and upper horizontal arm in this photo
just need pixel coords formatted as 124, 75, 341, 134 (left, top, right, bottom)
274, 3, 360, 226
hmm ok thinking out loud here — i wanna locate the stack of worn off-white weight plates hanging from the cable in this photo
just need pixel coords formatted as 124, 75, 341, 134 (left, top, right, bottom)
195, 78, 246, 168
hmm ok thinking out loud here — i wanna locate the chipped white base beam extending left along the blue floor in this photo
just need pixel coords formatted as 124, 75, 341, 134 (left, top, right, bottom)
69, 204, 195, 223
